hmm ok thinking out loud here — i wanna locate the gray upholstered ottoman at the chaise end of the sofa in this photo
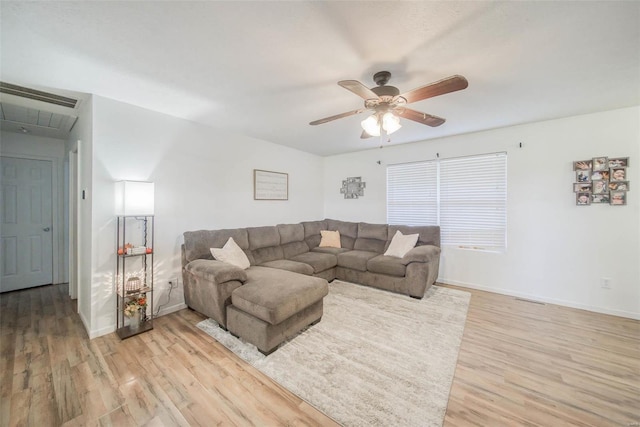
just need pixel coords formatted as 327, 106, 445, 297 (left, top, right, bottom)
227, 267, 329, 354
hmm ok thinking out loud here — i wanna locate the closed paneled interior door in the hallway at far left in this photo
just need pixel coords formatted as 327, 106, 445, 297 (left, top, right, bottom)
0, 157, 53, 292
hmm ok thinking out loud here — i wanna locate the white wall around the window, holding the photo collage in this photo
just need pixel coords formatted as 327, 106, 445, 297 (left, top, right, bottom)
324, 107, 640, 318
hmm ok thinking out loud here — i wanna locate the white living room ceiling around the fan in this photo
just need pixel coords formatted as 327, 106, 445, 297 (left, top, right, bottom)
0, 1, 640, 155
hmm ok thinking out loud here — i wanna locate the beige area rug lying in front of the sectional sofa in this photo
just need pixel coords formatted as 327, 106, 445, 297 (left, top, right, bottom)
198, 280, 470, 426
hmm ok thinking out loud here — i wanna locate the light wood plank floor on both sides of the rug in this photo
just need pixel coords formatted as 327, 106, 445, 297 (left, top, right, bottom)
0, 285, 640, 427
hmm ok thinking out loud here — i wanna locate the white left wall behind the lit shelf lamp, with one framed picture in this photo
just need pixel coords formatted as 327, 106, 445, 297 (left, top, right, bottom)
90, 96, 323, 336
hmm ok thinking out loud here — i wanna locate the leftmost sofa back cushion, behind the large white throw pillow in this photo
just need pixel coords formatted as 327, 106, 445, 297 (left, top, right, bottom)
183, 228, 253, 264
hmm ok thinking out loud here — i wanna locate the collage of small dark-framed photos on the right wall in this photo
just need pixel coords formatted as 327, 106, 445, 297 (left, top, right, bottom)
573, 157, 629, 206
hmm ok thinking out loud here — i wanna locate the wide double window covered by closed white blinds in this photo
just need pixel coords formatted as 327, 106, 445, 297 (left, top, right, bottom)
387, 153, 507, 251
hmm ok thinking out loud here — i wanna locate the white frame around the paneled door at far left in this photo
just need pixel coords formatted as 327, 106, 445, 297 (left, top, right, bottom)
1, 152, 65, 284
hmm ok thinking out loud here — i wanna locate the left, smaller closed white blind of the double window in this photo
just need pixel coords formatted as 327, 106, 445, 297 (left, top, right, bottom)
387, 161, 438, 225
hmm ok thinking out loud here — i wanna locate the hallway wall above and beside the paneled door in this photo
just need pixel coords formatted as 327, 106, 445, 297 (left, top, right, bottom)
0, 131, 68, 283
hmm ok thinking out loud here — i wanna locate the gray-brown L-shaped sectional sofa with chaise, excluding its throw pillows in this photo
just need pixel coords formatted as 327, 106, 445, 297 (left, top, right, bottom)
182, 219, 440, 354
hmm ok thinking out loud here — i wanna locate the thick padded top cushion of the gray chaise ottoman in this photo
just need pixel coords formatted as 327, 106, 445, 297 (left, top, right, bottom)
231, 266, 329, 325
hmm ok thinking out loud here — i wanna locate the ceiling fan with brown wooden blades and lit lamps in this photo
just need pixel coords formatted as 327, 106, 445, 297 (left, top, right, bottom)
309, 71, 469, 138
